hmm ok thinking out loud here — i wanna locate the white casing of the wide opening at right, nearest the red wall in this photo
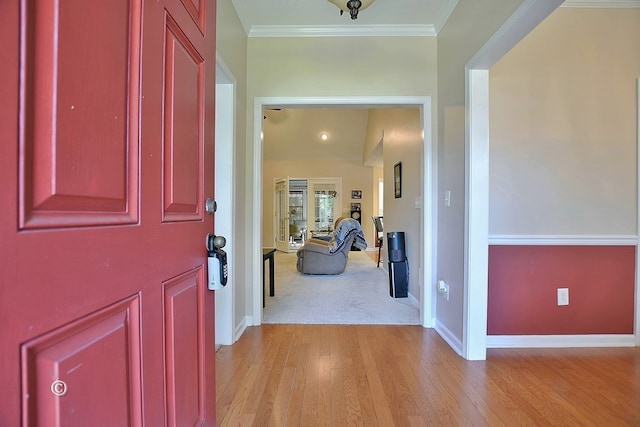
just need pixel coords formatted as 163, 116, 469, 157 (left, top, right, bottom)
462, 0, 563, 360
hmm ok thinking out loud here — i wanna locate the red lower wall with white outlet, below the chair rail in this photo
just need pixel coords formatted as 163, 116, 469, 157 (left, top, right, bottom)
487, 246, 635, 335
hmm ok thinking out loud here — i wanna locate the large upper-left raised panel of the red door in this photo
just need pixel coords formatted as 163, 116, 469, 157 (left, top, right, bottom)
20, 0, 141, 228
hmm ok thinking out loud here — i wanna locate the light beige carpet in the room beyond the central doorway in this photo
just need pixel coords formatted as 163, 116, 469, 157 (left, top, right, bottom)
263, 252, 420, 325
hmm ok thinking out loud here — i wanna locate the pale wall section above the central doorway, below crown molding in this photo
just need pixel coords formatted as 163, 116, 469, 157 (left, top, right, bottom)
248, 37, 436, 101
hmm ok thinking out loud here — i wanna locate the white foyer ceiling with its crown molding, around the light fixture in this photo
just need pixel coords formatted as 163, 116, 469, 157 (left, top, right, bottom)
232, 0, 458, 37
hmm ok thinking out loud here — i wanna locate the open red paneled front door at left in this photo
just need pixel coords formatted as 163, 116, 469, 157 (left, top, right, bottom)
0, 0, 216, 426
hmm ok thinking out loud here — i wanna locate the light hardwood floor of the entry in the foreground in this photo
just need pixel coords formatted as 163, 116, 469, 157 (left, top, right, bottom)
216, 325, 640, 427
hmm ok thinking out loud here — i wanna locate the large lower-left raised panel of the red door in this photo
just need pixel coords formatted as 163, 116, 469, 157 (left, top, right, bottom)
22, 297, 142, 427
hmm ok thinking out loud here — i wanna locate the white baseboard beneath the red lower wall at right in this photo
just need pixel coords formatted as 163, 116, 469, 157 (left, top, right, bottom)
487, 334, 636, 348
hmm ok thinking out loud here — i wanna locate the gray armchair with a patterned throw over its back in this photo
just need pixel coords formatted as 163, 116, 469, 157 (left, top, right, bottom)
296, 218, 367, 274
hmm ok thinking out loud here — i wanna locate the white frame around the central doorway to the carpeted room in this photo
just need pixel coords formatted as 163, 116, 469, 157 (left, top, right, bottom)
247, 96, 437, 327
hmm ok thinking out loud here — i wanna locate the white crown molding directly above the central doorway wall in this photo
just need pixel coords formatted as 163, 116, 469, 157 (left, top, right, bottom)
247, 25, 437, 37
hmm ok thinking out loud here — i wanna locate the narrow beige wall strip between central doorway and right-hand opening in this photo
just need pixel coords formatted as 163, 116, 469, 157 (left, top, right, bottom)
436, 0, 522, 351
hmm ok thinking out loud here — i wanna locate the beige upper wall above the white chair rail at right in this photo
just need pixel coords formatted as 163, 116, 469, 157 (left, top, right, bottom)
489, 8, 640, 236
